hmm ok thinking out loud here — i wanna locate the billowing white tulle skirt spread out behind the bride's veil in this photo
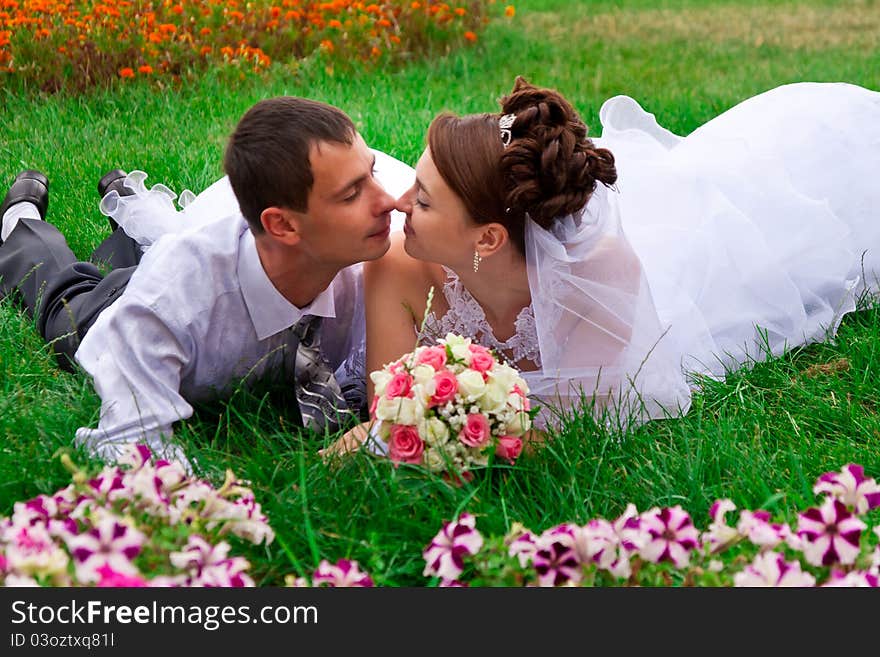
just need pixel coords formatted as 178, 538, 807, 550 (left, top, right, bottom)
595, 83, 880, 377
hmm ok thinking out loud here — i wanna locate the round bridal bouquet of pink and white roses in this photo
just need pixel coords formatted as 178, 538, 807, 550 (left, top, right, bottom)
370, 333, 532, 478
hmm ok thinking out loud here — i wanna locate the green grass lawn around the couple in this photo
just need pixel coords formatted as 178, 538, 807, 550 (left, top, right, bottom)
0, 0, 880, 585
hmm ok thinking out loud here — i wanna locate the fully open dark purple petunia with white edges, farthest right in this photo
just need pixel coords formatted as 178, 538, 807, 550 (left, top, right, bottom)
797, 497, 866, 566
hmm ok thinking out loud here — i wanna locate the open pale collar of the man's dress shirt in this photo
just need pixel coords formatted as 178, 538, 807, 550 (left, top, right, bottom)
238, 230, 336, 340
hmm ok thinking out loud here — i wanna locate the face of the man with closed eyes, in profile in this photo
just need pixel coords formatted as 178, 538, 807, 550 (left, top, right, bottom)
299, 135, 394, 267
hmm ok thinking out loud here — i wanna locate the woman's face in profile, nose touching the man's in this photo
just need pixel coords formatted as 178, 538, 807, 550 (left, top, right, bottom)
397, 149, 479, 270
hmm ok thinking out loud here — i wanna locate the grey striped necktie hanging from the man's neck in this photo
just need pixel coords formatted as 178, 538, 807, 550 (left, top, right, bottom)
293, 315, 348, 433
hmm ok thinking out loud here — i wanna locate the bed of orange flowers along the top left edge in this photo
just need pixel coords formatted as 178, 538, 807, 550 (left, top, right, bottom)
0, 0, 494, 91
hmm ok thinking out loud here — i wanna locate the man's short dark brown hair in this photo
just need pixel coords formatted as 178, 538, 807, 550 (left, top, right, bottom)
223, 96, 357, 234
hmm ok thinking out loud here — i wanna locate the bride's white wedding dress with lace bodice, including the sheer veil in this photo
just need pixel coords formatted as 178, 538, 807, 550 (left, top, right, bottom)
428, 83, 880, 424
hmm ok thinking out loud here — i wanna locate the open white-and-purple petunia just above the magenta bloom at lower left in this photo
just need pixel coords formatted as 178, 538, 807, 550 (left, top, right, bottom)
66, 512, 146, 583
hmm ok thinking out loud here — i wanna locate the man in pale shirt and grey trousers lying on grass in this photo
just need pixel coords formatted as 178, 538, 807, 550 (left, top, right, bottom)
0, 97, 406, 464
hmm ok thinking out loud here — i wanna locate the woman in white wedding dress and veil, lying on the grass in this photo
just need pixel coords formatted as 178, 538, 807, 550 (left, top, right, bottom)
332, 78, 880, 451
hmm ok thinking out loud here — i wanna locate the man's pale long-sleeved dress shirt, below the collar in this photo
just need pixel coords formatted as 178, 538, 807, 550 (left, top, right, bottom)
75, 214, 365, 461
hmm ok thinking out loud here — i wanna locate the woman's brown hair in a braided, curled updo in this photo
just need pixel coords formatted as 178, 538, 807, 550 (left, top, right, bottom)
428, 76, 617, 253
